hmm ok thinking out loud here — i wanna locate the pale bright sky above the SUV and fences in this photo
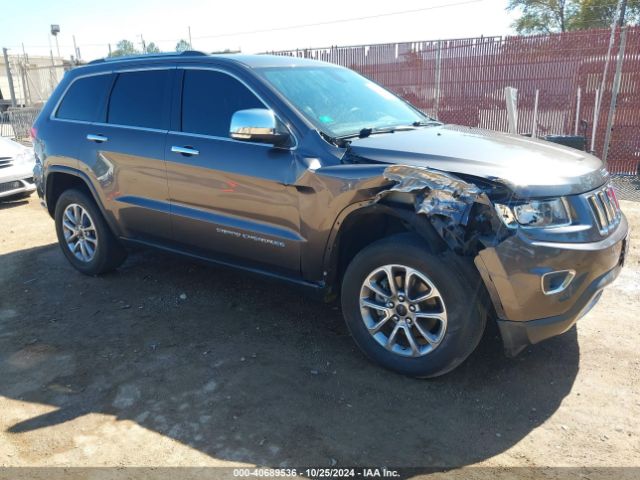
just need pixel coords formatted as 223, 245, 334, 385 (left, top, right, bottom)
0, 0, 514, 60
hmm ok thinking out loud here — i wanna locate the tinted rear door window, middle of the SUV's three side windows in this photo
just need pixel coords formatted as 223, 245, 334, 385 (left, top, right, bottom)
107, 70, 173, 130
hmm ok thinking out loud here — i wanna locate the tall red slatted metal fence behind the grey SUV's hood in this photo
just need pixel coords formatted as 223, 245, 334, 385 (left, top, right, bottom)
277, 27, 640, 173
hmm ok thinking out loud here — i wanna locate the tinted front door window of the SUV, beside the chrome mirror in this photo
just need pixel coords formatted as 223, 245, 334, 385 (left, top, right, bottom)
182, 70, 264, 137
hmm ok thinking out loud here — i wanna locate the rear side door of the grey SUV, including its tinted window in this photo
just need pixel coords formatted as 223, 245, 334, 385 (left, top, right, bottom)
84, 67, 175, 243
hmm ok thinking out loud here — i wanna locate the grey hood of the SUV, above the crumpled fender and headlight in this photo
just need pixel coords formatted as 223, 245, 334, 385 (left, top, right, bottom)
349, 125, 609, 198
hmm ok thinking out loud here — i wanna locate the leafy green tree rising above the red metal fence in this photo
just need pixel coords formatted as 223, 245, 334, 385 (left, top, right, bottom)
507, 0, 640, 34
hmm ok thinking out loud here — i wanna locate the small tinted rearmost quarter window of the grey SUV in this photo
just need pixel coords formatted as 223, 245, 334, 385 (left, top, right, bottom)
56, 74, 111, 122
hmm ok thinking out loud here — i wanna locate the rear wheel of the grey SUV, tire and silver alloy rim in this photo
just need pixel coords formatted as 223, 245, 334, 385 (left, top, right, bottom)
54, 189, 127, 275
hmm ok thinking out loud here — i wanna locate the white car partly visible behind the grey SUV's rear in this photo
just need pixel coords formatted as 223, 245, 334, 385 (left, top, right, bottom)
0, 137, 36, 200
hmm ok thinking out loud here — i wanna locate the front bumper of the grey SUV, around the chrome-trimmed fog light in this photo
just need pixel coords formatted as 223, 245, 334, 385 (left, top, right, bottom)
475, 215, 629, 355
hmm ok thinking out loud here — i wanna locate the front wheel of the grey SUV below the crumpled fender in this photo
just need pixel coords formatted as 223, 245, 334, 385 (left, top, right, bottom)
342, 234, 486, 378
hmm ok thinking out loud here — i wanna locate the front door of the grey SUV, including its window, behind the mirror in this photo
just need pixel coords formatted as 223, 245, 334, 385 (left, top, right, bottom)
165, 67, 303, 274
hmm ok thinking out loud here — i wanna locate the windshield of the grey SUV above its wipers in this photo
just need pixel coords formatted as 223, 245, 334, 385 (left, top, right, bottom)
261, 67, 430, 137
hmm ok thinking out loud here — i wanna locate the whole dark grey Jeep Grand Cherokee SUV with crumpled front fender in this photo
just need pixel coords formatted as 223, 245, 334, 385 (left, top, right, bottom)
33, 52, 628, 377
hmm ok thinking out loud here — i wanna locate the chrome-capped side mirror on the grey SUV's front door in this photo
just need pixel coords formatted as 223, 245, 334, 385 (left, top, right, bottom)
229, 108, 289, 147
